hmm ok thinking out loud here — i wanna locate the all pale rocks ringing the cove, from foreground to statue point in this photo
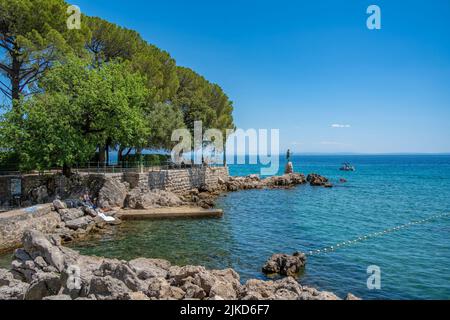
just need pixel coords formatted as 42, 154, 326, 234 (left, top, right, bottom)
0, 173, 356, 300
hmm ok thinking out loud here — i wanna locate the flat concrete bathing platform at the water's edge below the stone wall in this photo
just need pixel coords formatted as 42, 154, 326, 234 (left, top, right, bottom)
117, 207, 223, 220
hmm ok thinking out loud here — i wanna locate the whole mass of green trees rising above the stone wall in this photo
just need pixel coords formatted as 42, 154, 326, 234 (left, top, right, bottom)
0, 0, 234, 174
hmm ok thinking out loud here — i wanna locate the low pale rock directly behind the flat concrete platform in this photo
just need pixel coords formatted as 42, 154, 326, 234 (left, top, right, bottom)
125, 188, 183, 209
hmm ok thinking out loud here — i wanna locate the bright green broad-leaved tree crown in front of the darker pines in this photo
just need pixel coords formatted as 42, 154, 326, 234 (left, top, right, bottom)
1, 59, 149, 169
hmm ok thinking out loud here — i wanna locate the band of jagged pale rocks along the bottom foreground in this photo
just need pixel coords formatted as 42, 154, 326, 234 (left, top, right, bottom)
0, 231, 354, 300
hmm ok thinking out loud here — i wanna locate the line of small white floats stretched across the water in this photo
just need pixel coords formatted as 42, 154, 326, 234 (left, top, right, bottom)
305, 213, 450, 256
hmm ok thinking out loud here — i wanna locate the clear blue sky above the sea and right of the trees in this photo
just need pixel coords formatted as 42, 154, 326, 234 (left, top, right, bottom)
6, 0, 450, 153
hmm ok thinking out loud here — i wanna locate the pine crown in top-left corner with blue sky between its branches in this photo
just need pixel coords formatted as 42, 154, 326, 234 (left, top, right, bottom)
0, 0, 87, 100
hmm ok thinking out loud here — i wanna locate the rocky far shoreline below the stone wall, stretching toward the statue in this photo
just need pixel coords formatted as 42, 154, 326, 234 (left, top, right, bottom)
0, 173, 328, 252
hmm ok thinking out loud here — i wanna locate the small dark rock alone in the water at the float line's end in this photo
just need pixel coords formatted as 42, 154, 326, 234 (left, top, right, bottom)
262, 252, 306, 277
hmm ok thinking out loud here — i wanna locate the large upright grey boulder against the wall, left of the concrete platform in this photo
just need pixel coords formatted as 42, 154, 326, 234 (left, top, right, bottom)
97, 178, 129, 209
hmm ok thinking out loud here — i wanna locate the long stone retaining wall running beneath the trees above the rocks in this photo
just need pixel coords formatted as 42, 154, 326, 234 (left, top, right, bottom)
0, 167, 229, 205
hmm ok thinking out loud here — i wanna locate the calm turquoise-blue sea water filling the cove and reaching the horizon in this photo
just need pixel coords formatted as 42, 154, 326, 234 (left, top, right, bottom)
0, 156, 450, 299
